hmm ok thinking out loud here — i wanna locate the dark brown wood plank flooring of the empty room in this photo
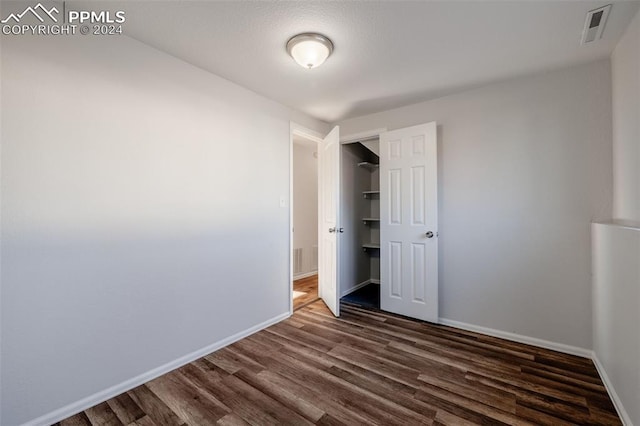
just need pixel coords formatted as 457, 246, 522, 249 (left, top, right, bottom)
59, 302, 621, 426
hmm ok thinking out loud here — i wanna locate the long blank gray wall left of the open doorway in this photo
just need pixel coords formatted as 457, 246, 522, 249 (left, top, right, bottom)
0, 36, 327, 425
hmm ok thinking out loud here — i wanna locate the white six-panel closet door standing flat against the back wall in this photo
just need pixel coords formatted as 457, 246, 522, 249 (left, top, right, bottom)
380, 122, 438, 322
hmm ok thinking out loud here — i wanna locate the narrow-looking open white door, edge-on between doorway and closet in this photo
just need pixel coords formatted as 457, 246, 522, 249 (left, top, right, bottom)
318, 126, 340, 316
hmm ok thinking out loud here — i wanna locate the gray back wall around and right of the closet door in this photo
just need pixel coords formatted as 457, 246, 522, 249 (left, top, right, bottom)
338, 60, 612, 348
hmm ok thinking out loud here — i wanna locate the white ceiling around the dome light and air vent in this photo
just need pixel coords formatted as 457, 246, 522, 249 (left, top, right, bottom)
109, 0, 640, 122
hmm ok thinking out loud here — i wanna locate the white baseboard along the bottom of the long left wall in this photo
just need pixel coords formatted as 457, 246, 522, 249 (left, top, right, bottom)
22, 312, 291, 426
